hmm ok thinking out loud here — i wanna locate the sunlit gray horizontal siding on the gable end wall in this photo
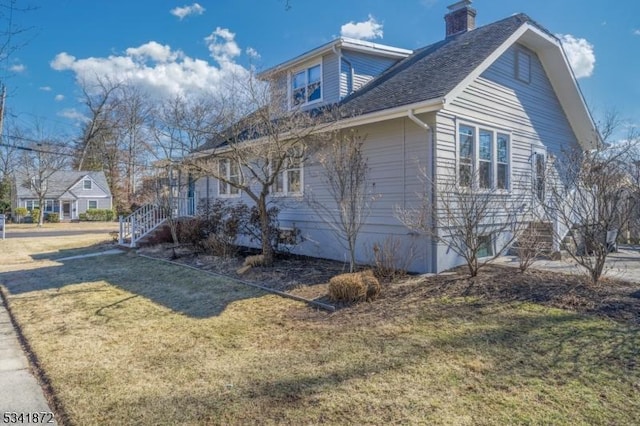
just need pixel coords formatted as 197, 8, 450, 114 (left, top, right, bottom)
436, 46, 578, 271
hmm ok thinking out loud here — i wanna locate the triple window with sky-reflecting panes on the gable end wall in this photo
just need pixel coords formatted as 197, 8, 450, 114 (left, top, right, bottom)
458, 124, 511, 190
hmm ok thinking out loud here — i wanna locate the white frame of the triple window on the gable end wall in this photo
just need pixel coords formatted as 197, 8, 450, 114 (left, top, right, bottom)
456, 121, 512, 192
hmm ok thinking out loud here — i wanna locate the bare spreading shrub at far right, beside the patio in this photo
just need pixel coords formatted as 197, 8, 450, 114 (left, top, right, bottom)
543, 144, 637, 284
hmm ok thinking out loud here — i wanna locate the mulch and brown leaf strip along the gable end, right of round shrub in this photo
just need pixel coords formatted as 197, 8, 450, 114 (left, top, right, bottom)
304, 265, 640, 325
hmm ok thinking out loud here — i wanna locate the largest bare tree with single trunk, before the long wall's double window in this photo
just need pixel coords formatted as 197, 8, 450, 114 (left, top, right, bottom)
191, 70, 330, 265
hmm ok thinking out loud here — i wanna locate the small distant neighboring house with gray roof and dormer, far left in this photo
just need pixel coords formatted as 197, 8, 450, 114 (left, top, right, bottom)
12, 171, 113, 220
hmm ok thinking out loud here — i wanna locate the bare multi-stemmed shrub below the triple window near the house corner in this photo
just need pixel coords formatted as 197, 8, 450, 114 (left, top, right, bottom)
396, 170, 527, 277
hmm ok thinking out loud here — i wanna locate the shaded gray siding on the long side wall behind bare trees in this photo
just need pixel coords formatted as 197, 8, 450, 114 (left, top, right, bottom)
196, 115, 432, 272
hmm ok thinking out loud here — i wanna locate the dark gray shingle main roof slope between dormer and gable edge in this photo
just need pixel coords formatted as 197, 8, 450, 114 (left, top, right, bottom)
341, 14, 546, 115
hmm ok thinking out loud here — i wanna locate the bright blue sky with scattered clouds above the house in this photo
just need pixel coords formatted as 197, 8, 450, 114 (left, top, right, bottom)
0, 0, 640, 137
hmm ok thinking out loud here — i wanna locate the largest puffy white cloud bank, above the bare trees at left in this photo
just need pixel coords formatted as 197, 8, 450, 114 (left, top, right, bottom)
50, 28, 253, 99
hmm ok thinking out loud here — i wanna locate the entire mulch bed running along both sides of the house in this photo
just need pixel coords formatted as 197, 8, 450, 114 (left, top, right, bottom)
135, 245, 640, 325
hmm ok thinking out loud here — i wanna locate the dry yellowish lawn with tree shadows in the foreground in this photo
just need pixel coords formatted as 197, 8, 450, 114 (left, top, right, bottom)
0, 235, 640, 425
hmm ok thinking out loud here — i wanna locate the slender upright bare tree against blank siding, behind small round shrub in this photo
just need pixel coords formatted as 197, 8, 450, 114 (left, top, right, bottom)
307, 131, 375, 272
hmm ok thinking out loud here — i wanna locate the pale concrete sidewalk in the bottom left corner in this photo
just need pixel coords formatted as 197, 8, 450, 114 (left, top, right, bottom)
0, 298, 52, 424
